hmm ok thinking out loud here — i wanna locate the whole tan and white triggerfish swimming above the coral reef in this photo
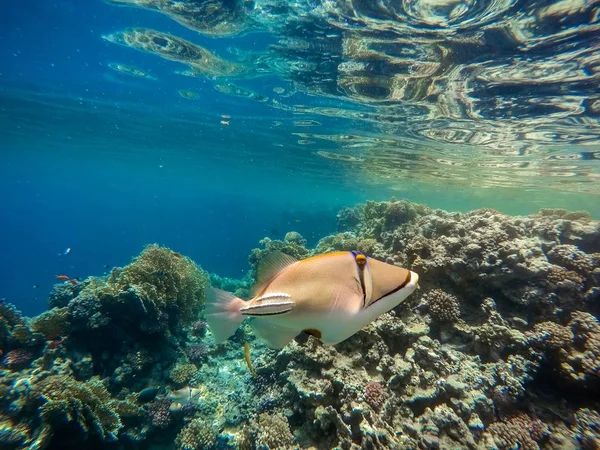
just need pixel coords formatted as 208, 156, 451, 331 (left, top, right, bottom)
206, 252, 419, 348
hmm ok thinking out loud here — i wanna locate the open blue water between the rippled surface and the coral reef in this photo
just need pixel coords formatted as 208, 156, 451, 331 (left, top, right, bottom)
0, 0, 600, 315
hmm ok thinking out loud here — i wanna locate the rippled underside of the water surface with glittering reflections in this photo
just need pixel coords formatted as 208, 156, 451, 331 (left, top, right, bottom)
92, 0, 600, 194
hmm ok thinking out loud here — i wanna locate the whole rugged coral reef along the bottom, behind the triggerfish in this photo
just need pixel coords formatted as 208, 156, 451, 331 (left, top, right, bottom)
0, 199, 600, 450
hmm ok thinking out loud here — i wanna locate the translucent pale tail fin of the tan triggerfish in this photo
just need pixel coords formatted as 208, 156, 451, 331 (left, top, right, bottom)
205, 288, 246, 344
